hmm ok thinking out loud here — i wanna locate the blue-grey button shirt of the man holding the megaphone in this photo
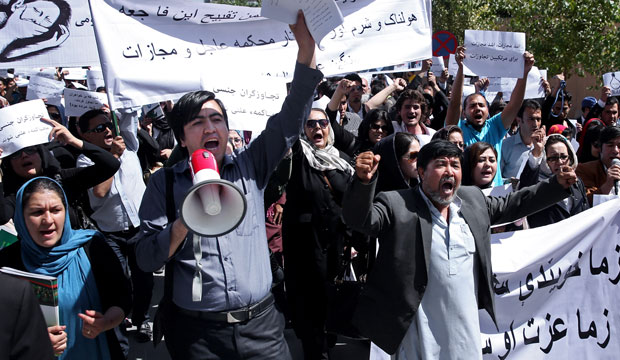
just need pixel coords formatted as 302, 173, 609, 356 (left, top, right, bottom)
136, 64, 323, 311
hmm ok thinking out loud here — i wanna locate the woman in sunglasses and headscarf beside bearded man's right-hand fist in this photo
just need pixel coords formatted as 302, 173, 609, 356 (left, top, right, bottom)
519, 129, 590, 228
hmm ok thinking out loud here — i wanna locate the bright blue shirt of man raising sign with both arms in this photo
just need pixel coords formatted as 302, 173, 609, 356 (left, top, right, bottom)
459, 113, 508, 186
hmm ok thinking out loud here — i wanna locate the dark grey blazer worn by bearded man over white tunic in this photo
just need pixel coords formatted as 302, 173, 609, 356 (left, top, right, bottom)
342, 177, 570, 354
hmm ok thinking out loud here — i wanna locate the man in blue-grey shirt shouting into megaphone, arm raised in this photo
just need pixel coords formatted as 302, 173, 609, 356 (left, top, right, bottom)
136, 12, 323, 359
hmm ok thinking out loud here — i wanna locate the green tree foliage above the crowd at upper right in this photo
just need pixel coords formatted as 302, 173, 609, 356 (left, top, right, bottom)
433, 0, 620, 76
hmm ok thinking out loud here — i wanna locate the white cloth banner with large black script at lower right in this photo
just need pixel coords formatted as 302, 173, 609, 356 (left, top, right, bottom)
480, 200, 620, 360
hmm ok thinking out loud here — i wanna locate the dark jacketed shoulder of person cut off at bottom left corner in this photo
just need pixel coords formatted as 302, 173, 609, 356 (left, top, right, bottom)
0, 273, 54, 360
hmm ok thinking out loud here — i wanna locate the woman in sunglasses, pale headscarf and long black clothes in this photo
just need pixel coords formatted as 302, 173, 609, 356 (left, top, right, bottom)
282, 108, 353, 359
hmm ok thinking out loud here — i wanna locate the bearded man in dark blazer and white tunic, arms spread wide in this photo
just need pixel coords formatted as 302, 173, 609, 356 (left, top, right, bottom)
343, 140, 577, 359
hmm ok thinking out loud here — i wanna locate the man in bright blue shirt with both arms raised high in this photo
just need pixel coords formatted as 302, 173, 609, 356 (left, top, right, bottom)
446, 46, 534, 186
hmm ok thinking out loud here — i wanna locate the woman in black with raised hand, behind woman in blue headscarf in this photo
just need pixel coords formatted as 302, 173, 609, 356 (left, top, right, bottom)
0, 118, 119, 229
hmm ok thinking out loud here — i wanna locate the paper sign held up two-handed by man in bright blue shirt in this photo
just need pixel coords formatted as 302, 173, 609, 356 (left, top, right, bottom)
464, 30, 525, 78
